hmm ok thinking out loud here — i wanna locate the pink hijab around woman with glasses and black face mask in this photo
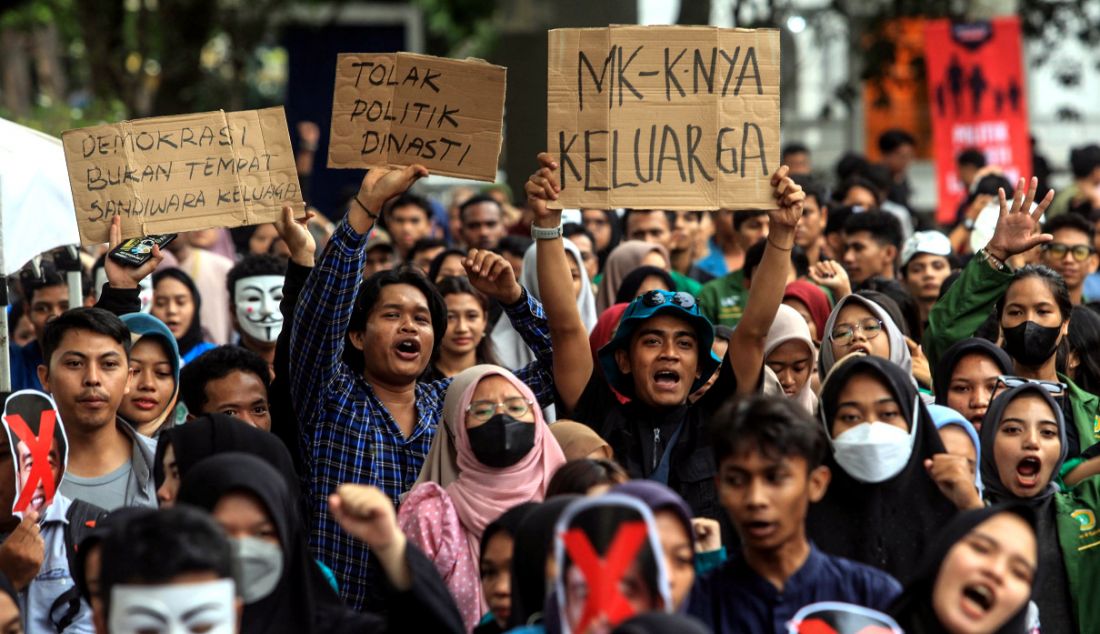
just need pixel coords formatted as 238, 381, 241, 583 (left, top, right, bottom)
417, 365, 565, 545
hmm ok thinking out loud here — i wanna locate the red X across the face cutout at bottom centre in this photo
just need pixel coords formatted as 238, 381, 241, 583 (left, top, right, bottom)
562, 522, 647, 633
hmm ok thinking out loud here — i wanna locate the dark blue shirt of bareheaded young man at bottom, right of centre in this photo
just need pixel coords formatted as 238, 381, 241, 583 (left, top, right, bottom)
688, 544, 901, 634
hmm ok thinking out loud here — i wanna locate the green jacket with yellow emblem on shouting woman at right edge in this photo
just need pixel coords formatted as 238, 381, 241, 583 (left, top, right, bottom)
1056, 459, 1100, 632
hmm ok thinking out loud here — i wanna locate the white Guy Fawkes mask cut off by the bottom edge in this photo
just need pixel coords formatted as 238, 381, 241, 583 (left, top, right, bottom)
109, 579, 237, 634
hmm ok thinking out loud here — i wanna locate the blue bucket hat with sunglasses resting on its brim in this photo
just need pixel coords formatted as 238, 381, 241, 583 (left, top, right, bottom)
600, 291, 722, 396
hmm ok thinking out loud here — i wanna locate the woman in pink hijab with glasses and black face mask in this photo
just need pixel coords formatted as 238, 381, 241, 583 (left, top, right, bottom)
397, 365, 565, 631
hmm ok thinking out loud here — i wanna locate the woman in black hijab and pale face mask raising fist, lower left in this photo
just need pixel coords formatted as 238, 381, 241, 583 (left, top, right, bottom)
179, 452, 463, 634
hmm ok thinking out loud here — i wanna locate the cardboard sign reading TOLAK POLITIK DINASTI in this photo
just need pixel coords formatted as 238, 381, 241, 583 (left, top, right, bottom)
329, 53, 506, 182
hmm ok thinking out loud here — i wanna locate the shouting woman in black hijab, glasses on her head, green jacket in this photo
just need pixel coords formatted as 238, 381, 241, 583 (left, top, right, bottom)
980, 378, 1100, 632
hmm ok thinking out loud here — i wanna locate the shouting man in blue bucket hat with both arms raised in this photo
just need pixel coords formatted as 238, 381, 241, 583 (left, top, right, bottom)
526, 154, 804, 522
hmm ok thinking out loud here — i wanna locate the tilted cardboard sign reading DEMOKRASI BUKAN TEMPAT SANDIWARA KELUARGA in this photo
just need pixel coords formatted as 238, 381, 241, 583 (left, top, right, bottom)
62, 107, 305, 244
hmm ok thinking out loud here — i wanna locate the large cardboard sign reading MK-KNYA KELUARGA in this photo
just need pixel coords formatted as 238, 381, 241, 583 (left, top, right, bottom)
547, 26, 779, 209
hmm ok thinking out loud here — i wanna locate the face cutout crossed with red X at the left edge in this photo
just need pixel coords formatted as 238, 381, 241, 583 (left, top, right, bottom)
3, 390, 68, 514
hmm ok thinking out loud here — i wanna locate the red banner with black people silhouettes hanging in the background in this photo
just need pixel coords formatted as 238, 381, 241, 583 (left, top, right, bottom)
924, 17, 1031, 225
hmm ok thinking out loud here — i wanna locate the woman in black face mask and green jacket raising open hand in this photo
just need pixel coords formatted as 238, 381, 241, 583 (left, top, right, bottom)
923, 178, 1100, 457
